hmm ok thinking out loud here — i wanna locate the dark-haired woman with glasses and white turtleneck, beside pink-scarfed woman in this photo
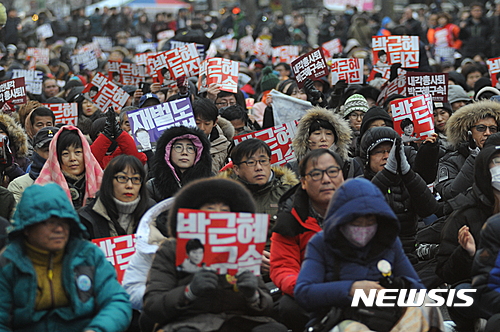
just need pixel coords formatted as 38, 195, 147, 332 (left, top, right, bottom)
79, 154, 155, 239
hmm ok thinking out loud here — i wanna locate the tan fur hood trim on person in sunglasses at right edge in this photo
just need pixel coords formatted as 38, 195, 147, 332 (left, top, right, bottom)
446, 100, 500, 148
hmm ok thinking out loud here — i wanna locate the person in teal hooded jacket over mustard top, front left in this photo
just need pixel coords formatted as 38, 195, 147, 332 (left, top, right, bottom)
0, 183, 132, 332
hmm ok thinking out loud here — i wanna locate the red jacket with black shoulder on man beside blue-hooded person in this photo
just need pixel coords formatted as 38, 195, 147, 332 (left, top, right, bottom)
270, 184, 321, 296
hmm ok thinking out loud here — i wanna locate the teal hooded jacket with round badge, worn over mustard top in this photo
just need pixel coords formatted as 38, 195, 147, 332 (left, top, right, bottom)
0, 183, 132, 332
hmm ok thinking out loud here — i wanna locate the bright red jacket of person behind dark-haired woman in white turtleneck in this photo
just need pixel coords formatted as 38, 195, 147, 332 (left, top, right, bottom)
90, 131, 148, 169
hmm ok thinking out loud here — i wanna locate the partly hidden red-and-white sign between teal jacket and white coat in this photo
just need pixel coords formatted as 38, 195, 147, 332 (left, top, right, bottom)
92, 234, 135, 284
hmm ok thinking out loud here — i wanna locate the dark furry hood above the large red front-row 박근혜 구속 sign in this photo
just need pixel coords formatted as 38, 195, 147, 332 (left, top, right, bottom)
168, 178, 256, 237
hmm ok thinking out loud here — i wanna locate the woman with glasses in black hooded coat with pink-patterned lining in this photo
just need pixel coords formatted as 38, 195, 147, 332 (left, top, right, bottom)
147, 126, 212, 202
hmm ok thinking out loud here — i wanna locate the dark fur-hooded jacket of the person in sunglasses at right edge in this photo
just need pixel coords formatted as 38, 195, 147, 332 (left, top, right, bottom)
435, 100, 500, 200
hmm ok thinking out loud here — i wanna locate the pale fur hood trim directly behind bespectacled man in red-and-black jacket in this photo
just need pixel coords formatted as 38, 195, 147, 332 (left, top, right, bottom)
292, 104, 352, 161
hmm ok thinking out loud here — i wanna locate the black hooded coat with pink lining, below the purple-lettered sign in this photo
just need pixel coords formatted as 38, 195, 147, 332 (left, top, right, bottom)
146, 126, 212, 202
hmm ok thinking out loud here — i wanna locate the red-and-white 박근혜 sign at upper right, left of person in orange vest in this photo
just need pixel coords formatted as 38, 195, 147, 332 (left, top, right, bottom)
372, 36, 420, 68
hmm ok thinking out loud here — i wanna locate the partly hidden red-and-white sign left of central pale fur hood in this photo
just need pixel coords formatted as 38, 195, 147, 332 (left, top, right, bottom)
234, 121, 298, 166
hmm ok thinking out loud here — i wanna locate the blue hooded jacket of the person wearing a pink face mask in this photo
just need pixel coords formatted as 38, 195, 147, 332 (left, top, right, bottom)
295, 178, 424, 315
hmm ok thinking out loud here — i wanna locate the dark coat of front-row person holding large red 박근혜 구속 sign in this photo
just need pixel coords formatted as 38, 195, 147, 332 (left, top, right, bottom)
143, 239, 273, 332
